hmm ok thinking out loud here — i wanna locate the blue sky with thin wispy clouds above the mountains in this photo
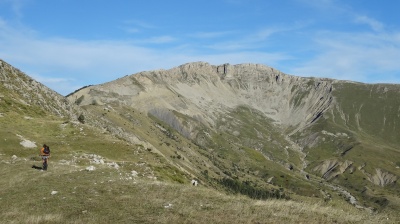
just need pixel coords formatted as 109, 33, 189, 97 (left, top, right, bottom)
0, 0, 400, 95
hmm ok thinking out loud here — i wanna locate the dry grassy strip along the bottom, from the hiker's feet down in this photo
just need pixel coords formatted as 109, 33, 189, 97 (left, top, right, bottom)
0, 160, 398, 223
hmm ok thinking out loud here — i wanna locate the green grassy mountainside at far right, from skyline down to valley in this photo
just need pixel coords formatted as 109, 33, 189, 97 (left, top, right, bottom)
296, 83, 400, 210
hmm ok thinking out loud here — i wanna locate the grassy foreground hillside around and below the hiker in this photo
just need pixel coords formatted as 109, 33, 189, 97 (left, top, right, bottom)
0, 103, 393, 223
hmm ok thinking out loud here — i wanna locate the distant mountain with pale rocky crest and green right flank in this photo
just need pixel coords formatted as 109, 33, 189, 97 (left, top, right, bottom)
69, 62, 400, 210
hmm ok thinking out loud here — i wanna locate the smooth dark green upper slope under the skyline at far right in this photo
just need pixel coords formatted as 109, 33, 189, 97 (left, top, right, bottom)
335, 83, 400, 144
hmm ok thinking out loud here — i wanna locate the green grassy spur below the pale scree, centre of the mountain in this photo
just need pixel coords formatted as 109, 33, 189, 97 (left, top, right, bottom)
208, 107, 319, 196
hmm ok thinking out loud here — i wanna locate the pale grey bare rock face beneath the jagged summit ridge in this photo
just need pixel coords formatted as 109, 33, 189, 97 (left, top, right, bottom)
69, 62, 334, 133
